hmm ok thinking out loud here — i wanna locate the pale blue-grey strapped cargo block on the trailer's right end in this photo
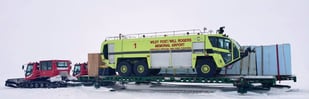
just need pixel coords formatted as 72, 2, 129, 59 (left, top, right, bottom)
220, 44, 292, 76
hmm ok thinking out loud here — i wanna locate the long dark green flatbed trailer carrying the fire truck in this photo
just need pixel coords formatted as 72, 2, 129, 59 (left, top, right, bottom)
78, 75, 296, 94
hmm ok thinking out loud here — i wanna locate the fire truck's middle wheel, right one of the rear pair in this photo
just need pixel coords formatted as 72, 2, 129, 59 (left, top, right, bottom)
133, 61, 150, 76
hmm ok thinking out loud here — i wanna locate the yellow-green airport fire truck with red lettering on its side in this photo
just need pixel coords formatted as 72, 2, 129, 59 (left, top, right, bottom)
101, 28, 241, 77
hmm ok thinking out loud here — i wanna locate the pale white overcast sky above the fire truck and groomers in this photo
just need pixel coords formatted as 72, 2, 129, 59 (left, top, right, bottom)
0, 0, 309, 85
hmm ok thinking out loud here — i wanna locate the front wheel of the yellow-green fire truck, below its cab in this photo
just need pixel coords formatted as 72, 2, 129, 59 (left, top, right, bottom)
196, 59, 217, 77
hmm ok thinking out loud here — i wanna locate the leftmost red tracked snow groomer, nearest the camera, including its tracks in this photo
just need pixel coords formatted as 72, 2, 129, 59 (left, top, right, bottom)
5, 60, 71, 88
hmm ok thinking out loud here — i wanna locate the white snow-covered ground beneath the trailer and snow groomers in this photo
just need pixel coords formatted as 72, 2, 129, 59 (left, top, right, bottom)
0, 72, 309, 99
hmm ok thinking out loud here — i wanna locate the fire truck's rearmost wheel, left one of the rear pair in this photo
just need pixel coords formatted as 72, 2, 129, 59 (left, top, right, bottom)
117, 61, 132, 76
